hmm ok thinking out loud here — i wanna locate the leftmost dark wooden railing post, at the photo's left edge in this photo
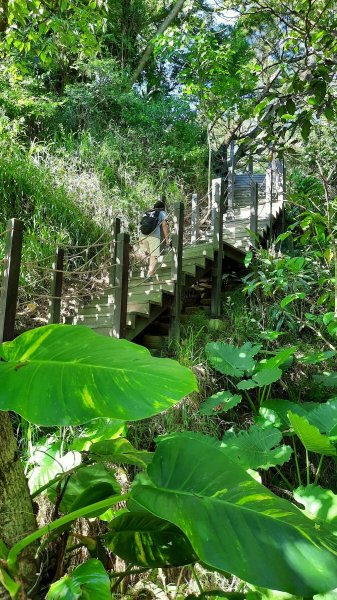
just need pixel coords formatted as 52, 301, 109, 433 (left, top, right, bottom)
0, 219, 23, 343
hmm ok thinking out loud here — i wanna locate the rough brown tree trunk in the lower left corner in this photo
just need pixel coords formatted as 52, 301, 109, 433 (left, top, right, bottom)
0, 411, 37, 599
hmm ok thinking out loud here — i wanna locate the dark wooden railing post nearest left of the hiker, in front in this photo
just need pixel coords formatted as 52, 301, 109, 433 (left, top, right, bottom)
113, 233, 130, 338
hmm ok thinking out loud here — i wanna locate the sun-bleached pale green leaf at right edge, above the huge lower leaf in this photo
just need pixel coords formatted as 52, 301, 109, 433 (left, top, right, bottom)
294, 484, 337, 535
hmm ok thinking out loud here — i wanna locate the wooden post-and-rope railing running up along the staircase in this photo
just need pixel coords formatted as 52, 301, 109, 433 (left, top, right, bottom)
0, 152, 285, 342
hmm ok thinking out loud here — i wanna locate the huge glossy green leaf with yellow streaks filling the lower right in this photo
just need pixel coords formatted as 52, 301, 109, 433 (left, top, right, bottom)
132, 433, 337, 596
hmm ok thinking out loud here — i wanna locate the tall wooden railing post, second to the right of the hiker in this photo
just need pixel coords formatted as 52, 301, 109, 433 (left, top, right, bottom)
211, 178, 228, 318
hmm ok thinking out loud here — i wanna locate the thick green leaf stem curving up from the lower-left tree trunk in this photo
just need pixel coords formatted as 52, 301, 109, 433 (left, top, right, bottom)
7, 494, 129, 572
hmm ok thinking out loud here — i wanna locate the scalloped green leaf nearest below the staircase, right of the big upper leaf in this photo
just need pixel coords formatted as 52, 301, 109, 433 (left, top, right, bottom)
206, 342, 261, 377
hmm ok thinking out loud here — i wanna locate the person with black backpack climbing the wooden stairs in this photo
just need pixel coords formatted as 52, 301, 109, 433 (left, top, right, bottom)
140, 200, 170, 277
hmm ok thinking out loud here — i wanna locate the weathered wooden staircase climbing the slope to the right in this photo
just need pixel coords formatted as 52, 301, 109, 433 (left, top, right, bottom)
67, 174, 283, 340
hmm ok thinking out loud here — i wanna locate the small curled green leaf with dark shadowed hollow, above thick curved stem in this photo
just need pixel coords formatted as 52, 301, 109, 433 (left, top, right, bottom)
48, 463, 120, 513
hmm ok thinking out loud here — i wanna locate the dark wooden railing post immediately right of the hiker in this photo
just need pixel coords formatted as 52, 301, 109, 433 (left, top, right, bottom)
170, 202, 184, 340
